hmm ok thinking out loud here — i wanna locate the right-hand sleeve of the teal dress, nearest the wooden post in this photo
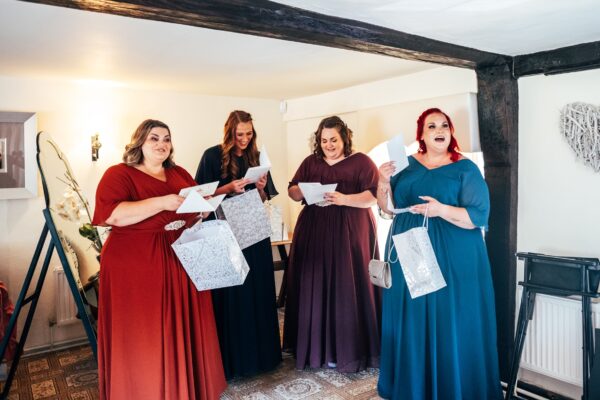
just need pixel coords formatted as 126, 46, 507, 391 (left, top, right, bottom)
458, 160, 490, 229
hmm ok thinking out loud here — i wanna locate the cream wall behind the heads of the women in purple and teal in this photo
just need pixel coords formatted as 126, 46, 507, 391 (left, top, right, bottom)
284, 67, 478, 228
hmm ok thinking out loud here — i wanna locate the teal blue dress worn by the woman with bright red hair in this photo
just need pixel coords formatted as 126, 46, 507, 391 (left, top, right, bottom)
377, 156, 502, 400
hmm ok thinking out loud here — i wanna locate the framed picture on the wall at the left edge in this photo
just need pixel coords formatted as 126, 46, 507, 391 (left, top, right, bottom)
0, 111, 38, 199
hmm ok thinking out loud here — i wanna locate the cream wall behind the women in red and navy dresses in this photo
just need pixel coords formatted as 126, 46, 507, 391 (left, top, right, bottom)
0, 76, 287, 349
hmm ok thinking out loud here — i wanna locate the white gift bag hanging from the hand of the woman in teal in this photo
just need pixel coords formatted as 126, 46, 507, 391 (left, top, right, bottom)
392, 211, 446, 299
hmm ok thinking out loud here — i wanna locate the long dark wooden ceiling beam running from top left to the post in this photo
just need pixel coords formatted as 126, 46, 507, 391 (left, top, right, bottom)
24, 0, 512, 68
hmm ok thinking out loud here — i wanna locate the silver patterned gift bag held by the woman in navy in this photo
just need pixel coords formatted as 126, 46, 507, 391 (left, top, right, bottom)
217, 189, 271, 250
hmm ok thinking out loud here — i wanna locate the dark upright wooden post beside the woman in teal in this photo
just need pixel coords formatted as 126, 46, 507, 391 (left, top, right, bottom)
476, 64, 519, 381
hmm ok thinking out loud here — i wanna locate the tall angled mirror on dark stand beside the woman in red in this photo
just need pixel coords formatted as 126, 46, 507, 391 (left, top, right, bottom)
37, 132, 102, 318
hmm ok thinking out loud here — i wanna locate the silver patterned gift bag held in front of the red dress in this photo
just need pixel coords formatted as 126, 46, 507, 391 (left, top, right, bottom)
171, 220, 250, 291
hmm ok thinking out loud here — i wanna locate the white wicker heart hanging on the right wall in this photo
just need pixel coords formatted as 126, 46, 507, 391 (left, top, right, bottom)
560, 103, 600, 172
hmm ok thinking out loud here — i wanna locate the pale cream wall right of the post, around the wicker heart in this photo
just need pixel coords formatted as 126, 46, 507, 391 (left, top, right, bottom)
517, 69, 600, 260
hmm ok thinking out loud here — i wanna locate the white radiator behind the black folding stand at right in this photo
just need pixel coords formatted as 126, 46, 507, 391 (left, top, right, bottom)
517, 287, 600, 386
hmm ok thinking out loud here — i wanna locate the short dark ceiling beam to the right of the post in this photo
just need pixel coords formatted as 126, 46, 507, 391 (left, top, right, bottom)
513, 42, 600, 78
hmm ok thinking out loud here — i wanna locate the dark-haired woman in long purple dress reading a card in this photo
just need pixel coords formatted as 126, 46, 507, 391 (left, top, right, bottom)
283, 116, 381, 372
